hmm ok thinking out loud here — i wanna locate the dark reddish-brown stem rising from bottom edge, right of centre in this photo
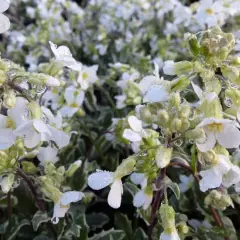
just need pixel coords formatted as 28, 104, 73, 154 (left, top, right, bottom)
148, 168, 166, 240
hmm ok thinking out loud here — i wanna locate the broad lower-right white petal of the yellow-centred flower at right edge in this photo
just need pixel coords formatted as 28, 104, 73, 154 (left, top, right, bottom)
215, 123, 240, 148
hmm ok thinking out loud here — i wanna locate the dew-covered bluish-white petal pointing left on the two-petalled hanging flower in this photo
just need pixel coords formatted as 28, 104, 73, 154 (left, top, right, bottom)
88, 171, 114, 190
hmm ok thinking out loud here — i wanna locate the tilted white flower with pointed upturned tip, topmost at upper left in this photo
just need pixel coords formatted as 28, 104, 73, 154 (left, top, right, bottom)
49, 41, 82, 71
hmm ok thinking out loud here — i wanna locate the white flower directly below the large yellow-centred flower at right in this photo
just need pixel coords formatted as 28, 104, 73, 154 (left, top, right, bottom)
199, 155, 231, 192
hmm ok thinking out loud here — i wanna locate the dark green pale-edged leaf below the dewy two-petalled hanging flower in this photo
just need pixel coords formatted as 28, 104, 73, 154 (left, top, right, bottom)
86, 213, 109, 230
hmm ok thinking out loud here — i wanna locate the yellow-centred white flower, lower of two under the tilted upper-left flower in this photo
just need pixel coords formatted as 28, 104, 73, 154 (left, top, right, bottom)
60, 86, 85, 117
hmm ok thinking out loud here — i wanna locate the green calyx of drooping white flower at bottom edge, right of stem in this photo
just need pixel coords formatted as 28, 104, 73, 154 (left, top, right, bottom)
160, 204, 175, 233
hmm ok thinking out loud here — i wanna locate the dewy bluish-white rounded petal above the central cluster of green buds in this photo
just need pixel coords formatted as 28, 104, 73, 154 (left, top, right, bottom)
143, 84, 169, 103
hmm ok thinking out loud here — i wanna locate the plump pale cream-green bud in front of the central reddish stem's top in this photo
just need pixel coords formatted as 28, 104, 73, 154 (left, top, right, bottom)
155, 145, 173, 168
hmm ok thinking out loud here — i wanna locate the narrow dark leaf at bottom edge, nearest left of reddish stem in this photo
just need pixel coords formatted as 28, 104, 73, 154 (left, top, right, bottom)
114, 213, 133, 240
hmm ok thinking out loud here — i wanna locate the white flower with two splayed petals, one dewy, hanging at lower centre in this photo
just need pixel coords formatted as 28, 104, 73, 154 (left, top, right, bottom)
88, 170, 123, 208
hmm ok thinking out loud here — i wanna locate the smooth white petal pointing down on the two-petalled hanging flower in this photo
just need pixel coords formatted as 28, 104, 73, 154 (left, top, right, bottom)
108, 179, 123, 209
